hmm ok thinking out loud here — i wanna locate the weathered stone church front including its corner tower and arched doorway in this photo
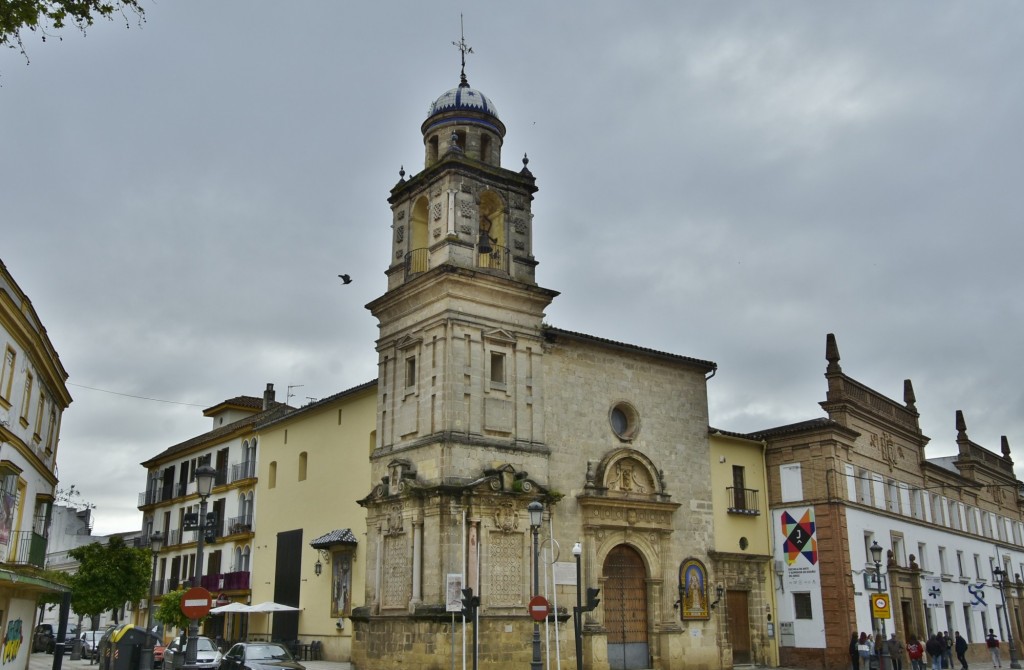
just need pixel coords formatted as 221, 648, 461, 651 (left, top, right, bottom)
352, 64, 722, 669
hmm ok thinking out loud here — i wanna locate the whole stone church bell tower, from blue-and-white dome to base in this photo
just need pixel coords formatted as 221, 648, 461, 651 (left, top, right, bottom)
353, 35, 558, 667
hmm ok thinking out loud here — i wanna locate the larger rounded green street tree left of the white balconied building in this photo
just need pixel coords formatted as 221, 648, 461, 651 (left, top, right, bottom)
68, 536, 152, 621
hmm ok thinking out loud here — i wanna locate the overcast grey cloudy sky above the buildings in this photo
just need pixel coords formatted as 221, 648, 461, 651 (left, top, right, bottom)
0, 0, 1024, 533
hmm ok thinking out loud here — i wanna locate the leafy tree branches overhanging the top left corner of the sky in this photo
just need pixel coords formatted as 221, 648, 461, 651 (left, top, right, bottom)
0, 0, 144, 55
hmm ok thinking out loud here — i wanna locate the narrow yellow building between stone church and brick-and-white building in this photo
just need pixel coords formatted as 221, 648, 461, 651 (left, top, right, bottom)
709, 428, 778, 667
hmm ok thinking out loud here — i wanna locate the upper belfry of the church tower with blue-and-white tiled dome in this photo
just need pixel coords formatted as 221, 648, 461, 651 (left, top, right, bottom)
388, 36, 537, 290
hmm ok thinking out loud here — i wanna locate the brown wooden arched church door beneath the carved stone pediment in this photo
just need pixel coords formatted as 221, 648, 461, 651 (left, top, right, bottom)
603, 544, 650, 670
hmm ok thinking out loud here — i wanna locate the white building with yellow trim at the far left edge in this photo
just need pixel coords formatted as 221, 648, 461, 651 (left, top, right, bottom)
0, 262, 72, 670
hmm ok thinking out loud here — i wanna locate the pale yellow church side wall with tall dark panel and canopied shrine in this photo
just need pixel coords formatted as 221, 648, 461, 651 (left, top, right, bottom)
249, 380, 377, 661
